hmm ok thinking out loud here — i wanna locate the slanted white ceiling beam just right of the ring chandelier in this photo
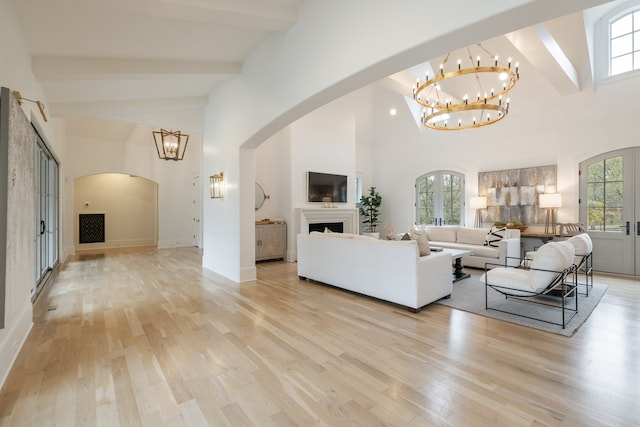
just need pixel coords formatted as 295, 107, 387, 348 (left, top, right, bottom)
506, 24, 580, 95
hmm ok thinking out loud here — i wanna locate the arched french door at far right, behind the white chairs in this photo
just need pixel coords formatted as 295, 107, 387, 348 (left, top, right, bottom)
580, 147, 640, 276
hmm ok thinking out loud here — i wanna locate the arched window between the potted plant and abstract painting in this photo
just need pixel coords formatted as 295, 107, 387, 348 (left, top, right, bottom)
416, 171, 464, 225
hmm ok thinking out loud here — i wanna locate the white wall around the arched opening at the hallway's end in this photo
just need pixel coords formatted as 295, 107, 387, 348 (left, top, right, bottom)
62, 117, 200, 253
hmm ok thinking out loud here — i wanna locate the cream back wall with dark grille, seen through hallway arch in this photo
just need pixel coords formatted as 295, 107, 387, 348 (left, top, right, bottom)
73, 173, 158, 250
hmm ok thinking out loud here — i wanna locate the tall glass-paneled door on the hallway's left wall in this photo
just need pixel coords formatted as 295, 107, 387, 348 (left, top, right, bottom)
31, 133, 59, 299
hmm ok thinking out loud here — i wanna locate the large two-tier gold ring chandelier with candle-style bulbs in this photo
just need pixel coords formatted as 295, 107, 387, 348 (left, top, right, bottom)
413, 43, 520, 130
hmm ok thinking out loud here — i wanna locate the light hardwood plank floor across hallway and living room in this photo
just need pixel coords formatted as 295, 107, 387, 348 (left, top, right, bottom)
0, 248, 640, 426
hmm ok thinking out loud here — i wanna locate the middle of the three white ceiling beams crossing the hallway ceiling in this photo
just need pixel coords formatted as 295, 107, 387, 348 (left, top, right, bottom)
31, 55, 242, 80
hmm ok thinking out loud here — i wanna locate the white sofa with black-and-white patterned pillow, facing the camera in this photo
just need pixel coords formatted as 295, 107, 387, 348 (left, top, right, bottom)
425, 225, 520, 269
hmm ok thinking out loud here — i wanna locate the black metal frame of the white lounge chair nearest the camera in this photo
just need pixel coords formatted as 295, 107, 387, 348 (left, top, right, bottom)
484, 258, 578, 329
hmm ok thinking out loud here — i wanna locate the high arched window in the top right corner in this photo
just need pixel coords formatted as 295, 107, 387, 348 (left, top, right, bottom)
609, 10, 640, 76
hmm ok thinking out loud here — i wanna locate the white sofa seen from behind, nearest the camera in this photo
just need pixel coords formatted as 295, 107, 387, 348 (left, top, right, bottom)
297, 232, 453, 312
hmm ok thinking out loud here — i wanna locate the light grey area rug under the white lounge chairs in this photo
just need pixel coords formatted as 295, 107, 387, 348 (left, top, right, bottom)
437, 269, 608, 337
